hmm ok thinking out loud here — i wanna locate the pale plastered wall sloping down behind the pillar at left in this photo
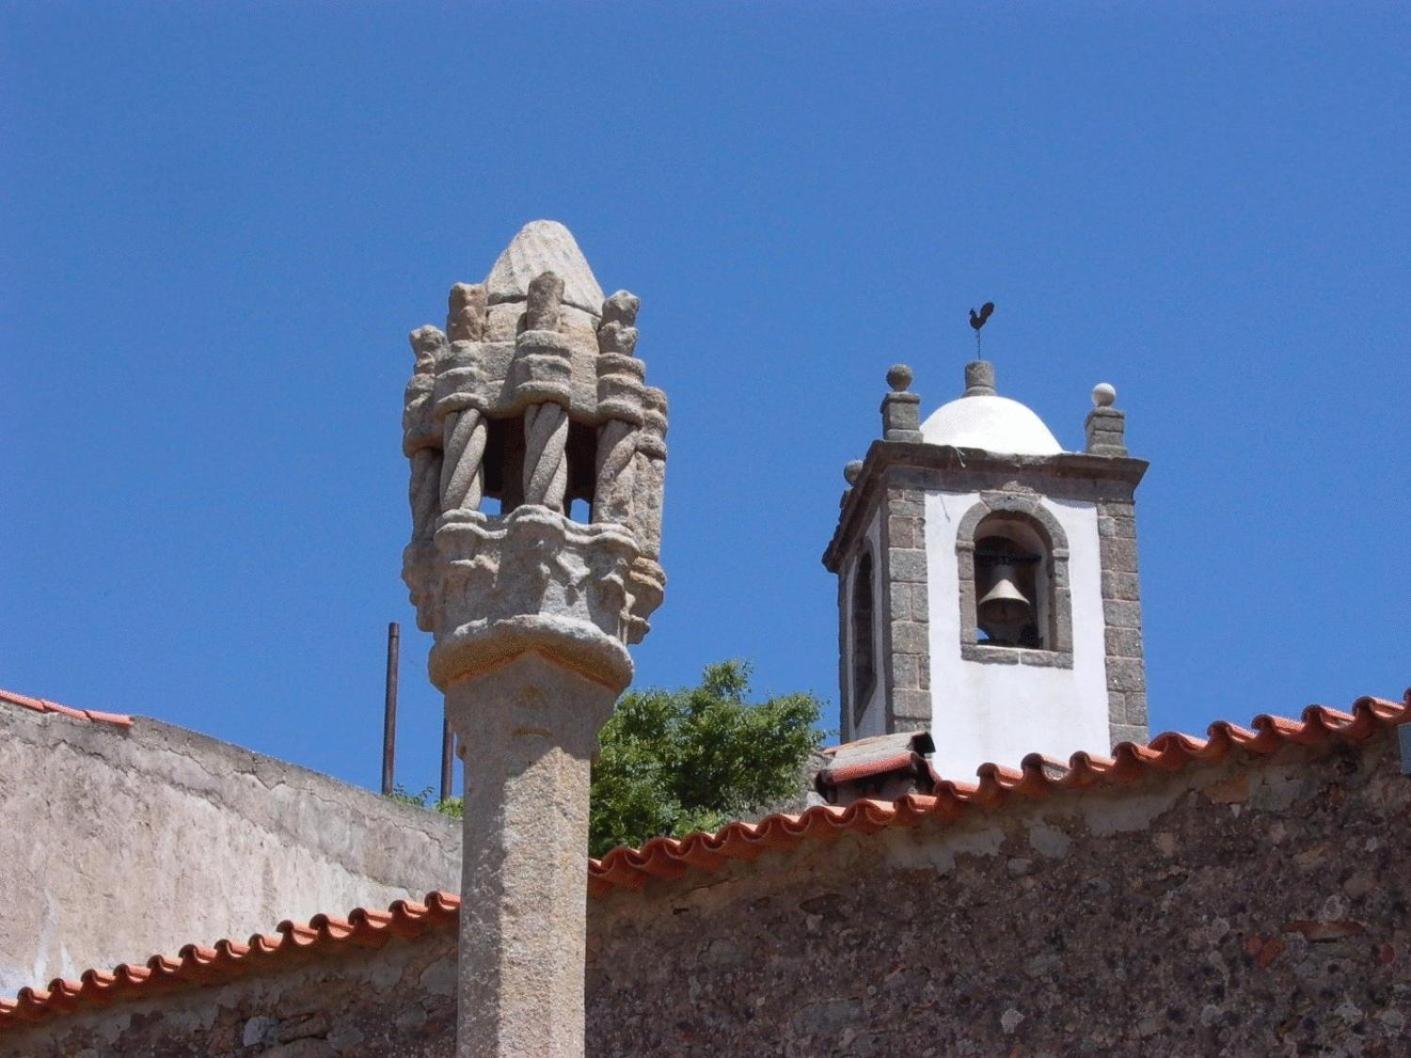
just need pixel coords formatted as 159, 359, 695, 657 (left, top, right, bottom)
0, 705, 460, 996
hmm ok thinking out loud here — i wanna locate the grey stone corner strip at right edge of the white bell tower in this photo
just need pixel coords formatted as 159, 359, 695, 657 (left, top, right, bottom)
1098, 498, 1147, 745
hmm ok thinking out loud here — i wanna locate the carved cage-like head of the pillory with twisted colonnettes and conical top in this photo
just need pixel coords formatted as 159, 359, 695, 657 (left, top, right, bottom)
402, 224, 666, 654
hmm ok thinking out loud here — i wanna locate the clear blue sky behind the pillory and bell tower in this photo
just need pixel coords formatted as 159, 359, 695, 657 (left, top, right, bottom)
0, 3, 1411, 787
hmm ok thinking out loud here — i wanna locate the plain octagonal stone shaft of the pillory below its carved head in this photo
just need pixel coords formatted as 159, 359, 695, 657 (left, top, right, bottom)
446, 652, 618, 1058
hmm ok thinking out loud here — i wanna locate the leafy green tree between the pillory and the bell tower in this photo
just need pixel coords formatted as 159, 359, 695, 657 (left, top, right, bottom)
588, 662, 823, 856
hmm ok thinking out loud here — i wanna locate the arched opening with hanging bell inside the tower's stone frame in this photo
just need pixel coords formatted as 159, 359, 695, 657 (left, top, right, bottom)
975, 512, 1054, 650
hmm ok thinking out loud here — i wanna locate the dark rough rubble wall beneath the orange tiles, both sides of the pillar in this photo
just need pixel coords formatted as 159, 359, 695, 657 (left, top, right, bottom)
0, 735, 1411, 1058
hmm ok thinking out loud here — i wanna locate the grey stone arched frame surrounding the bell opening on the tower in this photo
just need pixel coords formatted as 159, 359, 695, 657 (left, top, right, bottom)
955, 491, 1072, 669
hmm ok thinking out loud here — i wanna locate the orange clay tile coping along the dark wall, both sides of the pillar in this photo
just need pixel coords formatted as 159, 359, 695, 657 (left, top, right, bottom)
0, 690, 1411, 1033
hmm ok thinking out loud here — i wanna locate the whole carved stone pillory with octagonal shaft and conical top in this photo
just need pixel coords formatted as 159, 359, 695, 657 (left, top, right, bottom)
404, 220, 666, 1058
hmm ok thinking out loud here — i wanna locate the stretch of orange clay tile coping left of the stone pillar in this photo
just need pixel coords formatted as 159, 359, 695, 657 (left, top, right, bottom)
0, 893, 460, 1033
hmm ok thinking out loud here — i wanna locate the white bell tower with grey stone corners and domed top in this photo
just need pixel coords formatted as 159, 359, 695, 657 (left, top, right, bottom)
823, 360, 1147, 777
